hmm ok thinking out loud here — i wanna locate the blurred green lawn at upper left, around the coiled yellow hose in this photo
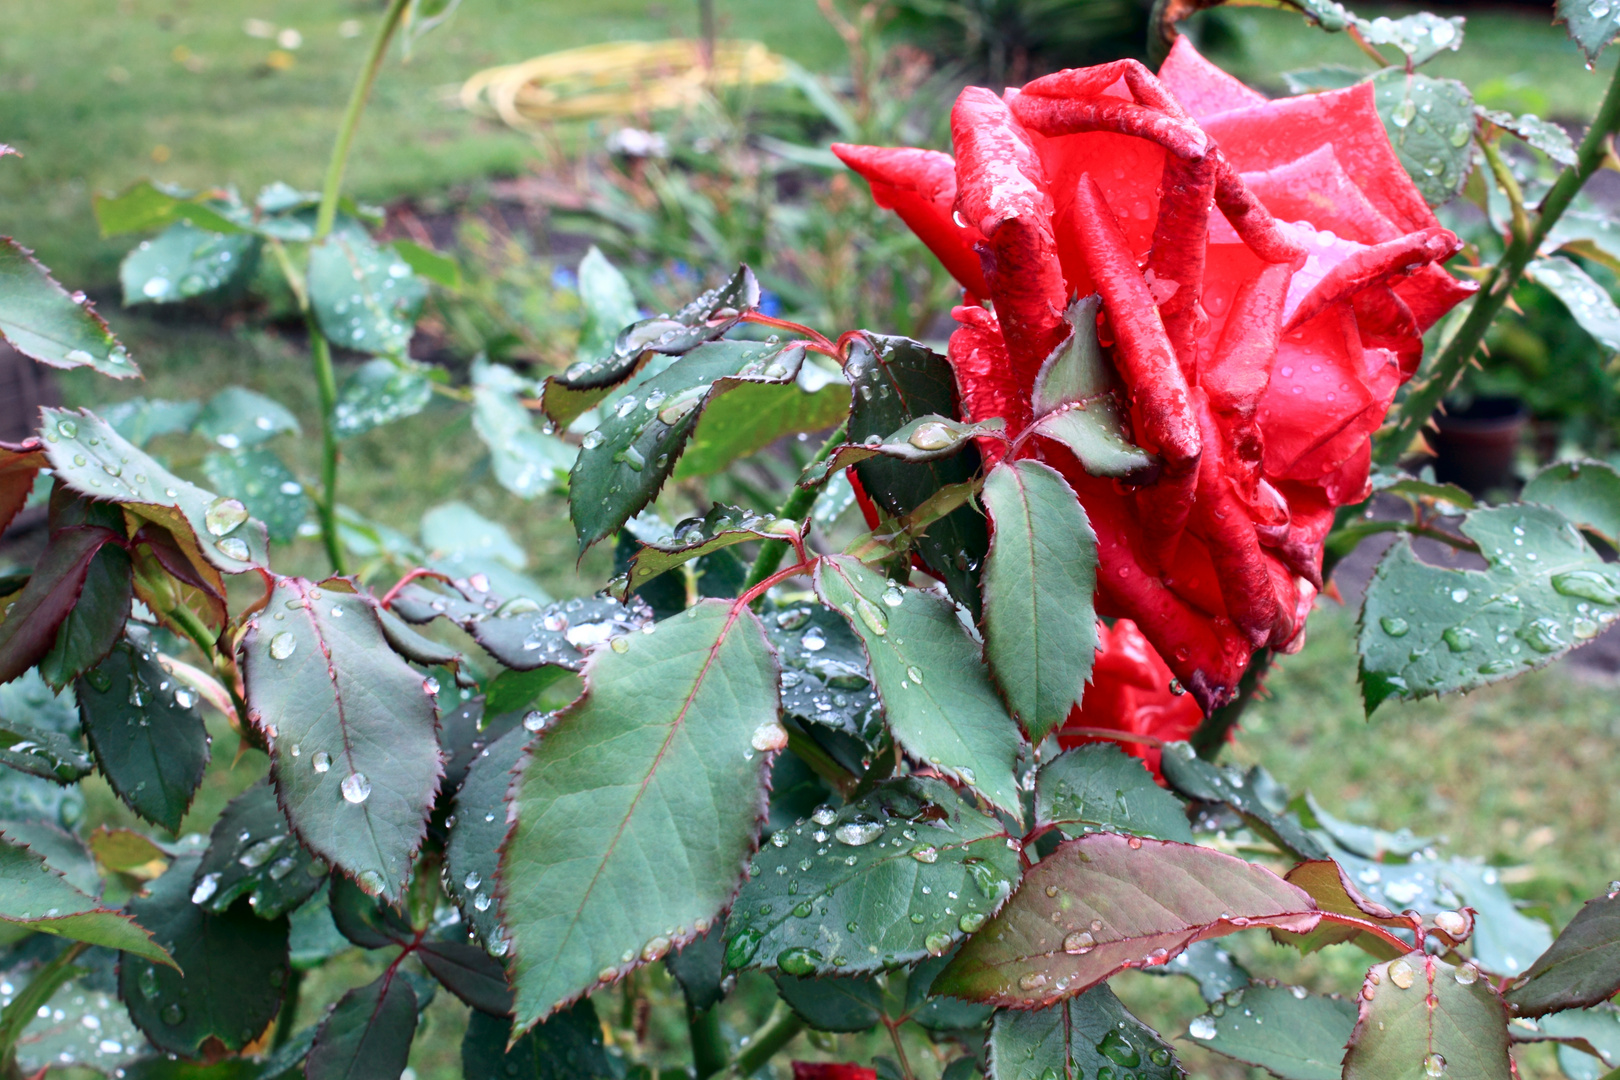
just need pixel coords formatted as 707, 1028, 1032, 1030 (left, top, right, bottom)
0, 0, 844, 287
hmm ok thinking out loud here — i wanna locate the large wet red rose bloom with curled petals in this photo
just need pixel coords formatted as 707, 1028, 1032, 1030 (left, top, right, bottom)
834, 37, 1473, 709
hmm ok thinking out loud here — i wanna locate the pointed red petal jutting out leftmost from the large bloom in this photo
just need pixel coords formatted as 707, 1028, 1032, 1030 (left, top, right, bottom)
833, 142, 990, 296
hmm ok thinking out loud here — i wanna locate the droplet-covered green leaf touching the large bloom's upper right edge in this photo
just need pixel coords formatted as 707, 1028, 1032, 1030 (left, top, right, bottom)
1372, 68, 1474, 206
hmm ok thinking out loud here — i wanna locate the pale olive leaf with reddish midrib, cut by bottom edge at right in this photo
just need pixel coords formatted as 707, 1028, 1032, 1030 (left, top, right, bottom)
1343, 952, 1513, 1080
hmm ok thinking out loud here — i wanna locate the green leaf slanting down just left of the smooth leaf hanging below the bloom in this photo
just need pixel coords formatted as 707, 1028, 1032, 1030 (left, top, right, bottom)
815, 555, 1024, 821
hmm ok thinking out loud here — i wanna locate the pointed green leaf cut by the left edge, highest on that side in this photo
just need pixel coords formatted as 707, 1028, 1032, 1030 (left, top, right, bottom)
0, 236, 141, 379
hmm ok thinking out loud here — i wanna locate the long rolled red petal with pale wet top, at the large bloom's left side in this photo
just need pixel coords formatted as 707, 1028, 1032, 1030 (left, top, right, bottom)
951, 86, 1068, 393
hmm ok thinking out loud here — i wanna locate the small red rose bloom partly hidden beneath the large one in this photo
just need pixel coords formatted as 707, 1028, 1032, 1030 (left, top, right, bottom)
1058, 619, 1204, 777
